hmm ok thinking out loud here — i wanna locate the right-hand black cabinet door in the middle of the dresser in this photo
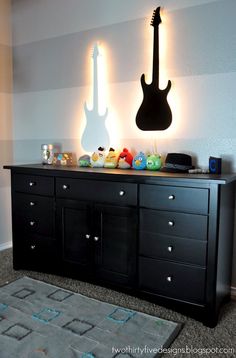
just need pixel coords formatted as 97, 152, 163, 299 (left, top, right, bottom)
94, 205, 137, 285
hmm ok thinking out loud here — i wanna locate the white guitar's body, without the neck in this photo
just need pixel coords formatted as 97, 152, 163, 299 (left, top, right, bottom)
81, 103, 110, 152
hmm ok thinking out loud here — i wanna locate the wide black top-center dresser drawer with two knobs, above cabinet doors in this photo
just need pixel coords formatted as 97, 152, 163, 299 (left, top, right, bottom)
56, 178, 137, 205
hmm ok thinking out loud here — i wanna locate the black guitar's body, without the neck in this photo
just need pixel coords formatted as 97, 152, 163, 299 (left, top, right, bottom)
136, 75, 172, 131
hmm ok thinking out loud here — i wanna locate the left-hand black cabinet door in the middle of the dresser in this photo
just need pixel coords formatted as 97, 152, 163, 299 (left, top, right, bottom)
57, 199, 93, 275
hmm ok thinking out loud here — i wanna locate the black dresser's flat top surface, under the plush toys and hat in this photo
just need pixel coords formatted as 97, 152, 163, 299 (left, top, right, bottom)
4, 164, 236, 184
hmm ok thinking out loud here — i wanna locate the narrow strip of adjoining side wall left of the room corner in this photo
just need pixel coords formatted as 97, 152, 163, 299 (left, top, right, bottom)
0, 0, 13, 249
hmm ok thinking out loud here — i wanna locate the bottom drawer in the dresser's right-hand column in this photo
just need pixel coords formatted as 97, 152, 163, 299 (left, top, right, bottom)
139, 257, 205, 303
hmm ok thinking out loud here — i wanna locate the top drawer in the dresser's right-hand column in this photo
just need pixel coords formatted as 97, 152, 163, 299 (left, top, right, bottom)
140, 184, 208, 214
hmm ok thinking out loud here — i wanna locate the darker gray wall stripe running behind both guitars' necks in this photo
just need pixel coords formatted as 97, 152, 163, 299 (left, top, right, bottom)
13, 0, 236, 92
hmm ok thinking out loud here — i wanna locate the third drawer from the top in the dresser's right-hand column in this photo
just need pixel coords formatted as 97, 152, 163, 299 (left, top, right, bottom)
139, 231, 207, 266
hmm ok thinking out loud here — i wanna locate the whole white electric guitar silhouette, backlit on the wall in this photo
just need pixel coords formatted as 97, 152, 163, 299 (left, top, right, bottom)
81, 44, 110, 152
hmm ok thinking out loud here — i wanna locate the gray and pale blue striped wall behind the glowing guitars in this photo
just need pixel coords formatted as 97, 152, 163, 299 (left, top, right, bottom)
12, 0, 236, 286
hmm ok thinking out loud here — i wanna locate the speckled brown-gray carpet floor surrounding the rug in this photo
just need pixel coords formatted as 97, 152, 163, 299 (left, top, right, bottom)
0, 249, 236, 358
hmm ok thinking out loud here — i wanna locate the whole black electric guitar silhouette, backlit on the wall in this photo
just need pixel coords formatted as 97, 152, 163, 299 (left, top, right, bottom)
136, 7, 172, 131
